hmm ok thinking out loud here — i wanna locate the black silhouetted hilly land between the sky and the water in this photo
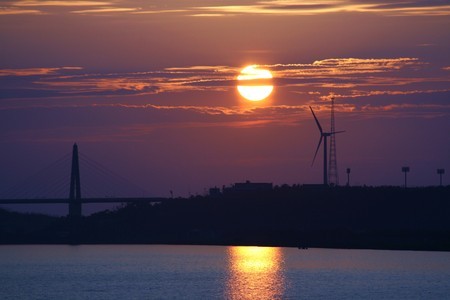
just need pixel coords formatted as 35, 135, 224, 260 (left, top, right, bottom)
0, 185, 450, 251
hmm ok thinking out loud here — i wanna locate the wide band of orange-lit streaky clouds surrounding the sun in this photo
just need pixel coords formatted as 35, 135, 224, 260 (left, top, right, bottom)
0, 57, 450, 122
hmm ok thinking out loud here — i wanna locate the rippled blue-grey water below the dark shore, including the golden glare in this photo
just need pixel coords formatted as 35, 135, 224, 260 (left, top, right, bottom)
0, 245, 450, 299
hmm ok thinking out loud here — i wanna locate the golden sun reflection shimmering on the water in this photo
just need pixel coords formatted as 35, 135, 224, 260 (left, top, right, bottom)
226, 247, 284, 299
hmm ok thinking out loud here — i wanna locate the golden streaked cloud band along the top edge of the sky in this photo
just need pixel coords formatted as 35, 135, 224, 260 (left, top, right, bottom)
0, 0, 450, 17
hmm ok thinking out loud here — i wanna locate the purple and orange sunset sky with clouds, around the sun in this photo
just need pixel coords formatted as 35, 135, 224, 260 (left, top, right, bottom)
0, 0, 450, 204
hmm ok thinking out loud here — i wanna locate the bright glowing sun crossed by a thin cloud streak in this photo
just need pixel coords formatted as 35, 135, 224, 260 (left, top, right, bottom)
237, 65, 273, 101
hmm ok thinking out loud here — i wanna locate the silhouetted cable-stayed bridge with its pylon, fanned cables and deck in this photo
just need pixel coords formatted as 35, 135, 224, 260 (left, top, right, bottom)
0, 144, 168, 218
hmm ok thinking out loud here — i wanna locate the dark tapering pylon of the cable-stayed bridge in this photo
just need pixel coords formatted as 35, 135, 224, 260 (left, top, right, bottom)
69, 143, 81, 218
